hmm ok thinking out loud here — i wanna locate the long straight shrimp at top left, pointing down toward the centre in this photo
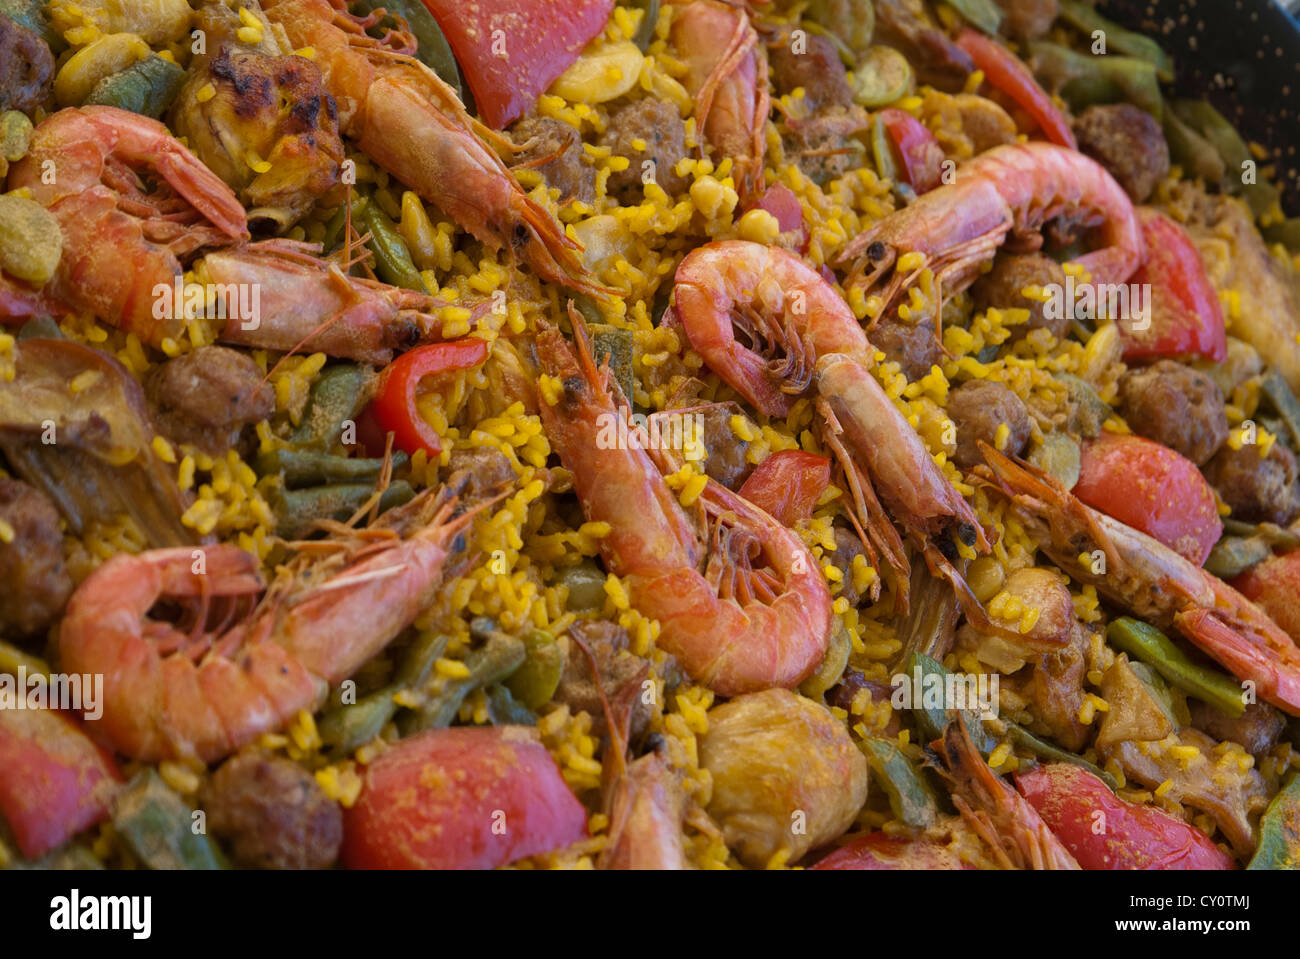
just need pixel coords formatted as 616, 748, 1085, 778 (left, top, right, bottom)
263, 0, 610, 296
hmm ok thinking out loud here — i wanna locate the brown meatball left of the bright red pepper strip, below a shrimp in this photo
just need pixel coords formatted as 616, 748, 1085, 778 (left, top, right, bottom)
144, 346, 276, 456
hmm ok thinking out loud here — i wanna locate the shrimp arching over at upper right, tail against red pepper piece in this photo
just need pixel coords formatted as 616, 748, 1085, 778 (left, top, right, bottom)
836, 142, 1147, 324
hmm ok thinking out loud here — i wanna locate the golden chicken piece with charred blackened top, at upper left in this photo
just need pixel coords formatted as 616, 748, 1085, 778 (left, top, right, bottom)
170, 45, 347, 233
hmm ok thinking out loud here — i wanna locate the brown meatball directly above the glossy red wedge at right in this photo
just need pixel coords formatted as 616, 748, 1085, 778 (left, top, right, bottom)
1119, 360, 1227, 467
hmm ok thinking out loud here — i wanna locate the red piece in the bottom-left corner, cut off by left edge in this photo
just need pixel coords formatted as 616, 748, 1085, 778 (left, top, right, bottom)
0, 708, 121, 859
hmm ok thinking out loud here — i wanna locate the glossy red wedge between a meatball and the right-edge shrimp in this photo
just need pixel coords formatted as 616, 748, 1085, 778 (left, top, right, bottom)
1074, 433, 1223, 565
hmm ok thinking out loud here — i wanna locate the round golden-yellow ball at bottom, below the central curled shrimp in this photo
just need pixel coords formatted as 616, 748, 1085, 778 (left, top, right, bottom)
699, 689, 867, 867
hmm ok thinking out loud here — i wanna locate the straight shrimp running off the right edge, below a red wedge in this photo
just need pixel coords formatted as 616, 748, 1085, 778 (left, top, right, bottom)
980, 443, 1300, 716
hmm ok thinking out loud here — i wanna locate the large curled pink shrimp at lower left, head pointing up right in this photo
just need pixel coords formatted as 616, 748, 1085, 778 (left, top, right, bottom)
59, 496, 472, 763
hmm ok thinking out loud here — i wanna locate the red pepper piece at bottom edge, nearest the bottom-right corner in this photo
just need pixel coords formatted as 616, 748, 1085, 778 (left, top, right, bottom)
1015, 763, 1232, 869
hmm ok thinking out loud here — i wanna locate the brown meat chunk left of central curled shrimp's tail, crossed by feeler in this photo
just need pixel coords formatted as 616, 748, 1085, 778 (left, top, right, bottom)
555, 620, 653, 745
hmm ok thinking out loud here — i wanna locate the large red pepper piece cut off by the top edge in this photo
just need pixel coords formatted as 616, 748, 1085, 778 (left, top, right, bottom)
424, 0, 614, 130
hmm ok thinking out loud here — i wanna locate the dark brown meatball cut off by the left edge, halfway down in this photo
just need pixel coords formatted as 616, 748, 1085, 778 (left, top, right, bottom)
0, 480, 73, 637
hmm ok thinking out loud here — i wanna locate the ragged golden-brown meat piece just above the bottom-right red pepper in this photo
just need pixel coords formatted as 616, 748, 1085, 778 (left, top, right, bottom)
1097, 728, 1269, 856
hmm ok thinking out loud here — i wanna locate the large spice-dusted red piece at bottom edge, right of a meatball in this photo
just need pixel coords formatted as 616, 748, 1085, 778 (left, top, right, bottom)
342, 726, 586, 869
